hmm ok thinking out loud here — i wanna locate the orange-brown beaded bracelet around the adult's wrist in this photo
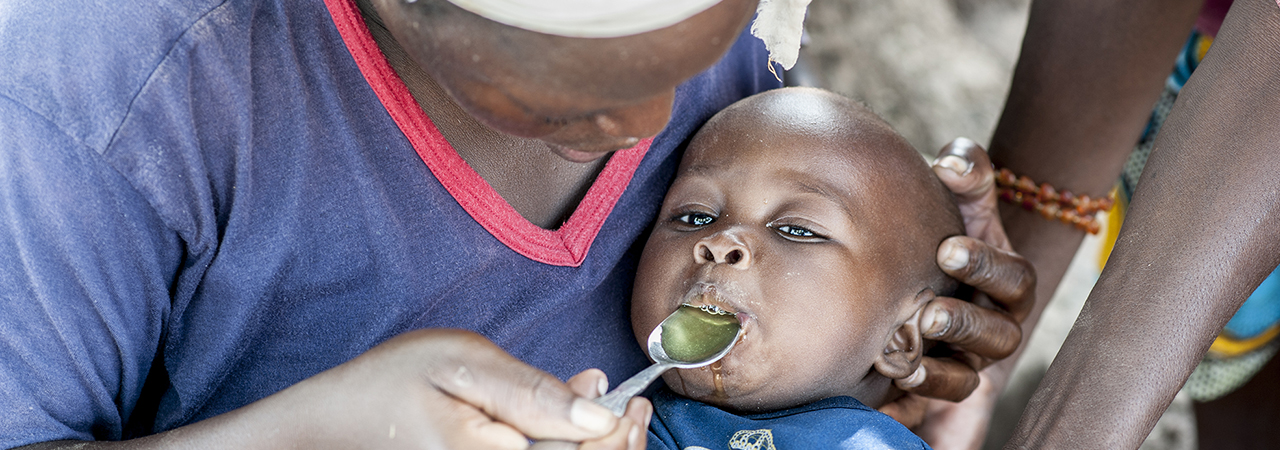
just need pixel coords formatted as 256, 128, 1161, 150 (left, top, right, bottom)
996, 167, 1116, 234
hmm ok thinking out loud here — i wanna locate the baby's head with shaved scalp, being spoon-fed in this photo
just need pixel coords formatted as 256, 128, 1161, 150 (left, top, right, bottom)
631, 88, 964, 412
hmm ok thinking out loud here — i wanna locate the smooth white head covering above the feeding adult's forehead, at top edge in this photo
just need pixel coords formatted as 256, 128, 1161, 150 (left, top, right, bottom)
448, 0, 721, 37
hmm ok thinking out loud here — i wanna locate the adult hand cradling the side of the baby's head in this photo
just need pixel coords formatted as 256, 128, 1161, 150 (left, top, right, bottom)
881, 138, 1036, 444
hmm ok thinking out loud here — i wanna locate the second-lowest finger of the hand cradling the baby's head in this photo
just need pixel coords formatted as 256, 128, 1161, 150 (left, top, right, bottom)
920, 297, 1023, 360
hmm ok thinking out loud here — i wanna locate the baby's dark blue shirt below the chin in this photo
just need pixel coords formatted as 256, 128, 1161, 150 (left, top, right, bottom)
649, 387, 929, 450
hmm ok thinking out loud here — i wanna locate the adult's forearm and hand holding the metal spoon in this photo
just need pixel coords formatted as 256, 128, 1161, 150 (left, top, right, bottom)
23, 330, 640, 449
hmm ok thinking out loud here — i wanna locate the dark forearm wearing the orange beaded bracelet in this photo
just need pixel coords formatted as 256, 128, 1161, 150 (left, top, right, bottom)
991, 0, 1201, 357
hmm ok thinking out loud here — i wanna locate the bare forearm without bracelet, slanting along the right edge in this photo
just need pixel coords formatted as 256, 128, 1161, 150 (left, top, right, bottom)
1010, 0, 1280, 447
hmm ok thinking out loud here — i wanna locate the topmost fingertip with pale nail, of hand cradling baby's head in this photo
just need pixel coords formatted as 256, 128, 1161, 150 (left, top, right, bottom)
933, 138, 996, 202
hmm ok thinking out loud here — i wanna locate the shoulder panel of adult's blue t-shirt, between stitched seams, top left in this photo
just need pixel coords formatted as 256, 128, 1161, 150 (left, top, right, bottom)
0, 0, 238, 150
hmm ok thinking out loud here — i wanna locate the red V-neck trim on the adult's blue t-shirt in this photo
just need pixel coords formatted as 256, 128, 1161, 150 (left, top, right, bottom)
325, 0, 653, 267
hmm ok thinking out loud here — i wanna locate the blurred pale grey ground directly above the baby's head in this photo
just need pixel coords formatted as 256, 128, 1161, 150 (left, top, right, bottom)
801, 0, 1028, 155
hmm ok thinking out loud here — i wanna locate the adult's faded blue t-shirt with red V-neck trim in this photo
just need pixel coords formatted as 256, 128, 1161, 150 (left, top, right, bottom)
0, 0, 778, 447
